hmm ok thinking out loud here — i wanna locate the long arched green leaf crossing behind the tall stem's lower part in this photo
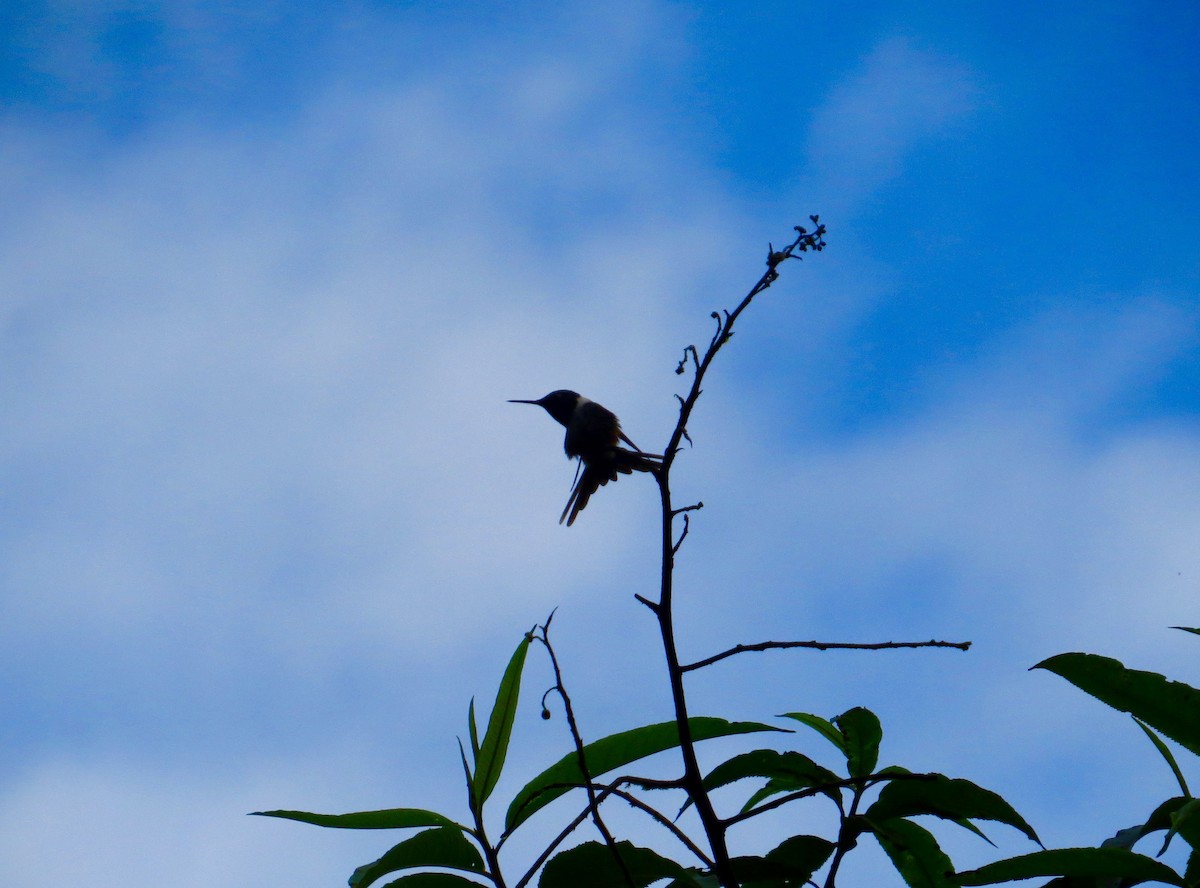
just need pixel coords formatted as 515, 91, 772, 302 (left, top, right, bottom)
504, 716, 780, 834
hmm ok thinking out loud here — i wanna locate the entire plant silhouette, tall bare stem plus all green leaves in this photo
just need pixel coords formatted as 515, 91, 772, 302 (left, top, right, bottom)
258, 223, 1200, 888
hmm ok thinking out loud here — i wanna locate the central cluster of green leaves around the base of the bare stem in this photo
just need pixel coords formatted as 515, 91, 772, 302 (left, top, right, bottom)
259, 626, 1037, 888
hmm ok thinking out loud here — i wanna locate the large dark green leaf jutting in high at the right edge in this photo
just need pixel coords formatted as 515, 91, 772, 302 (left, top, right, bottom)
1033, 654, 1200, 755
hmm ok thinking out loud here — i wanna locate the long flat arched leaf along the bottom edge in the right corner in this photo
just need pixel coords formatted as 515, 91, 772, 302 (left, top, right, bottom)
955, 848, 1183, 886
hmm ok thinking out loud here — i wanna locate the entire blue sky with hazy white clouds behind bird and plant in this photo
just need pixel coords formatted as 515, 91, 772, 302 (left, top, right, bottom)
0, 0, 1200, 888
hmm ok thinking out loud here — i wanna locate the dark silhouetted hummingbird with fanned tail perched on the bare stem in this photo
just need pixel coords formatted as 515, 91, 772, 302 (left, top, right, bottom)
509, 389, 662, 527
